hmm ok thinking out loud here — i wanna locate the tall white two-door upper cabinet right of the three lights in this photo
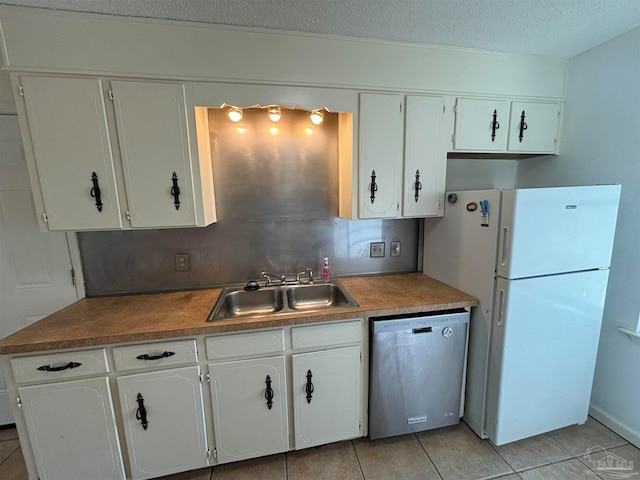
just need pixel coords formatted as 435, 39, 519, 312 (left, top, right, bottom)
359, 94, 446, 218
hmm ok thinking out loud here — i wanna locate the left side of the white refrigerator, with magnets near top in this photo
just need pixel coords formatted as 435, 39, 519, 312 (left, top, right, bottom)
423, 190, 501, 437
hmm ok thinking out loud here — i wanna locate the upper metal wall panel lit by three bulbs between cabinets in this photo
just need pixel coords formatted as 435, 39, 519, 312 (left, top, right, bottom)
209, 108, 338, 220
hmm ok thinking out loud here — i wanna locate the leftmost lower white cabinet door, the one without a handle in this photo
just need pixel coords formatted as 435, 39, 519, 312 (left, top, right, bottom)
18, 377, 125, 480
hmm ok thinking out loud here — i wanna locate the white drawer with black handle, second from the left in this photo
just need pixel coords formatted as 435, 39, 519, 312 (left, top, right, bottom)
113, 338, 198, 371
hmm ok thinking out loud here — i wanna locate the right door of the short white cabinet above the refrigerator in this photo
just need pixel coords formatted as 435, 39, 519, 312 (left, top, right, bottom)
507, 102, 560, 153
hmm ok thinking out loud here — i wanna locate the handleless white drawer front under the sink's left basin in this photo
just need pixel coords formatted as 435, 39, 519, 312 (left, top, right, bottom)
206, 329, 284, 360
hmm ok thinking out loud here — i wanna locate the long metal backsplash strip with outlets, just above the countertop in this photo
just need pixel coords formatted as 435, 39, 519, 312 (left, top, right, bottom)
78, 217, 420, 296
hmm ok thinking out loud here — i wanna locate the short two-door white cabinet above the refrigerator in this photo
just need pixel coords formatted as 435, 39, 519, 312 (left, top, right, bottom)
453, 98, 560, 153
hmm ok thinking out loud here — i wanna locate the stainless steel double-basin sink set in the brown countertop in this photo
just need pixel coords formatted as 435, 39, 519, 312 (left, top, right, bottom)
207, 280, 359, 322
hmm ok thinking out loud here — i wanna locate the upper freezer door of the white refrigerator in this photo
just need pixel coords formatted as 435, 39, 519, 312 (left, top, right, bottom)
497, 185, 620, 279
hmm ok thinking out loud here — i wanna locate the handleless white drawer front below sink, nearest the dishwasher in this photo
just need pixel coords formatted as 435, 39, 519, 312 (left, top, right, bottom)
291, 320, 362, 349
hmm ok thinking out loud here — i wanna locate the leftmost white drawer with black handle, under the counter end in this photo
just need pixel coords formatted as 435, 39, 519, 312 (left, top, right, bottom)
11, 348, 109, 383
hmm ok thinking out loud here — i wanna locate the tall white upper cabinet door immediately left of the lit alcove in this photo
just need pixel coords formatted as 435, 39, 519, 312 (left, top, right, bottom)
111, 81, 196, 227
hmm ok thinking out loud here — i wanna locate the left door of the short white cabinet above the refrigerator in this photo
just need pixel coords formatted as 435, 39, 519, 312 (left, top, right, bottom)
453, 98, 509, 152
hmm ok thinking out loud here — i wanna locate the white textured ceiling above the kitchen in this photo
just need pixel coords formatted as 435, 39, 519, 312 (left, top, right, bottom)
0, 0, 640, 58
